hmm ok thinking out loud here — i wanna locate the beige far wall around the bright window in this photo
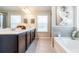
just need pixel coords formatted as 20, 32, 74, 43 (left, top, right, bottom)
35, 11, 51, 37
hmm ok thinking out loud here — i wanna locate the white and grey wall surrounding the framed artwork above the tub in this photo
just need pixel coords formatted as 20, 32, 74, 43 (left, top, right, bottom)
52, 7, 76, 37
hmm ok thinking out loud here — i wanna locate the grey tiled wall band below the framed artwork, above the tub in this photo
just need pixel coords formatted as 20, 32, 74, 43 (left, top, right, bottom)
53, 27, 75, 37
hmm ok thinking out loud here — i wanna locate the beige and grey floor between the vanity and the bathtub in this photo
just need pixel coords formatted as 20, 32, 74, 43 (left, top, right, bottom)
26, 38, 55, 53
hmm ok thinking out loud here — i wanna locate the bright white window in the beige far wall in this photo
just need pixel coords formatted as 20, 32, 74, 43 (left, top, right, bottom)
37, 15, 48, 32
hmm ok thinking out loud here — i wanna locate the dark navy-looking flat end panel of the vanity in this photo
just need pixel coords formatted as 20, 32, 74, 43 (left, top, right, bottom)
0, 35, 18, 53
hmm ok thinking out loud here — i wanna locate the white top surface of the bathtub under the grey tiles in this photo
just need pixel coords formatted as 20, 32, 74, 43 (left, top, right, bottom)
55, 37, 79, 53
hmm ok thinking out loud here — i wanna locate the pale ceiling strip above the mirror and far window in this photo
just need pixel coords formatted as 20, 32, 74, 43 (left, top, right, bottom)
0, 6, 51, 12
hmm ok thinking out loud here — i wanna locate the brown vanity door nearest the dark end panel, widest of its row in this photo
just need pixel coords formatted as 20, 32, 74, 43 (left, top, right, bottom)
18, 33, 26, 53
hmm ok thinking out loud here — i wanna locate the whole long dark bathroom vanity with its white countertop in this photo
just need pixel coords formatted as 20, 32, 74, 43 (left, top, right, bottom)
0, 28, 36, 53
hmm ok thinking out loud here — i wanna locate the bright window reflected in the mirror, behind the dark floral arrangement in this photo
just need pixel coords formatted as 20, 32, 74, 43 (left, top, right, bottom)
11, 15, 21, 28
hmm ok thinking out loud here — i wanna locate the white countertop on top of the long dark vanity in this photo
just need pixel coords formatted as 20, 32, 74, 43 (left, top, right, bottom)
0, 28, 34, 35
